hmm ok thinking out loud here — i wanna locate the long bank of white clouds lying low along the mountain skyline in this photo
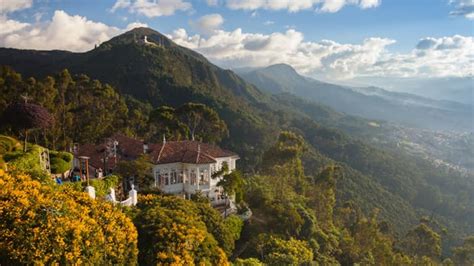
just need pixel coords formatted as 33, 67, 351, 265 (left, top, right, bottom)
0, 7, 468, 80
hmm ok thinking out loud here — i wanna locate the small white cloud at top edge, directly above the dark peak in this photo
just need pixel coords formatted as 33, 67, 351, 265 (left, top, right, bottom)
111, 0, 192, 18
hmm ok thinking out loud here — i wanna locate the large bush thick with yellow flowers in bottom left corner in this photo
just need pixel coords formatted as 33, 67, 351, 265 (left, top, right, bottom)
0, 170, 138, 265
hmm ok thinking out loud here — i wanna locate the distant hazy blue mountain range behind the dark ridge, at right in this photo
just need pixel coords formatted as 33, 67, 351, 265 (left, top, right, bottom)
239, 64, 474, 131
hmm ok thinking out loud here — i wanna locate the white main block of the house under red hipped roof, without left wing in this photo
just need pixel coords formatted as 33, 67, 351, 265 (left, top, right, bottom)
151, 138, 239, 204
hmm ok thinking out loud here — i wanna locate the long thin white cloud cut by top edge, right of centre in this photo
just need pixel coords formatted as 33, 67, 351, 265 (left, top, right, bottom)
222, 0, 381, 13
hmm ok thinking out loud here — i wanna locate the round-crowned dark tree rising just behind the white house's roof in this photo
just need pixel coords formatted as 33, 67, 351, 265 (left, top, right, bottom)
176, 103, 229, 143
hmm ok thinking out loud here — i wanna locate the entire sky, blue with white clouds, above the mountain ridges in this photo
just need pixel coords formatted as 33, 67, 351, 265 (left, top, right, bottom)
0, 0, 474, 87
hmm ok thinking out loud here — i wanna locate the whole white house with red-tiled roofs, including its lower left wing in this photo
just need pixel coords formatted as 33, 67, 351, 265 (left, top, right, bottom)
74, 134, 239, 205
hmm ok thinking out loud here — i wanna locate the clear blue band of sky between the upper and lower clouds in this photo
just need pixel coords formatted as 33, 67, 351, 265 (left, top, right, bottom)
6, 0, 474, 51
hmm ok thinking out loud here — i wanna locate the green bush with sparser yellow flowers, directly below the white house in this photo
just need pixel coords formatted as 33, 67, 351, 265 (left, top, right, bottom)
134, 195, 229, 265
